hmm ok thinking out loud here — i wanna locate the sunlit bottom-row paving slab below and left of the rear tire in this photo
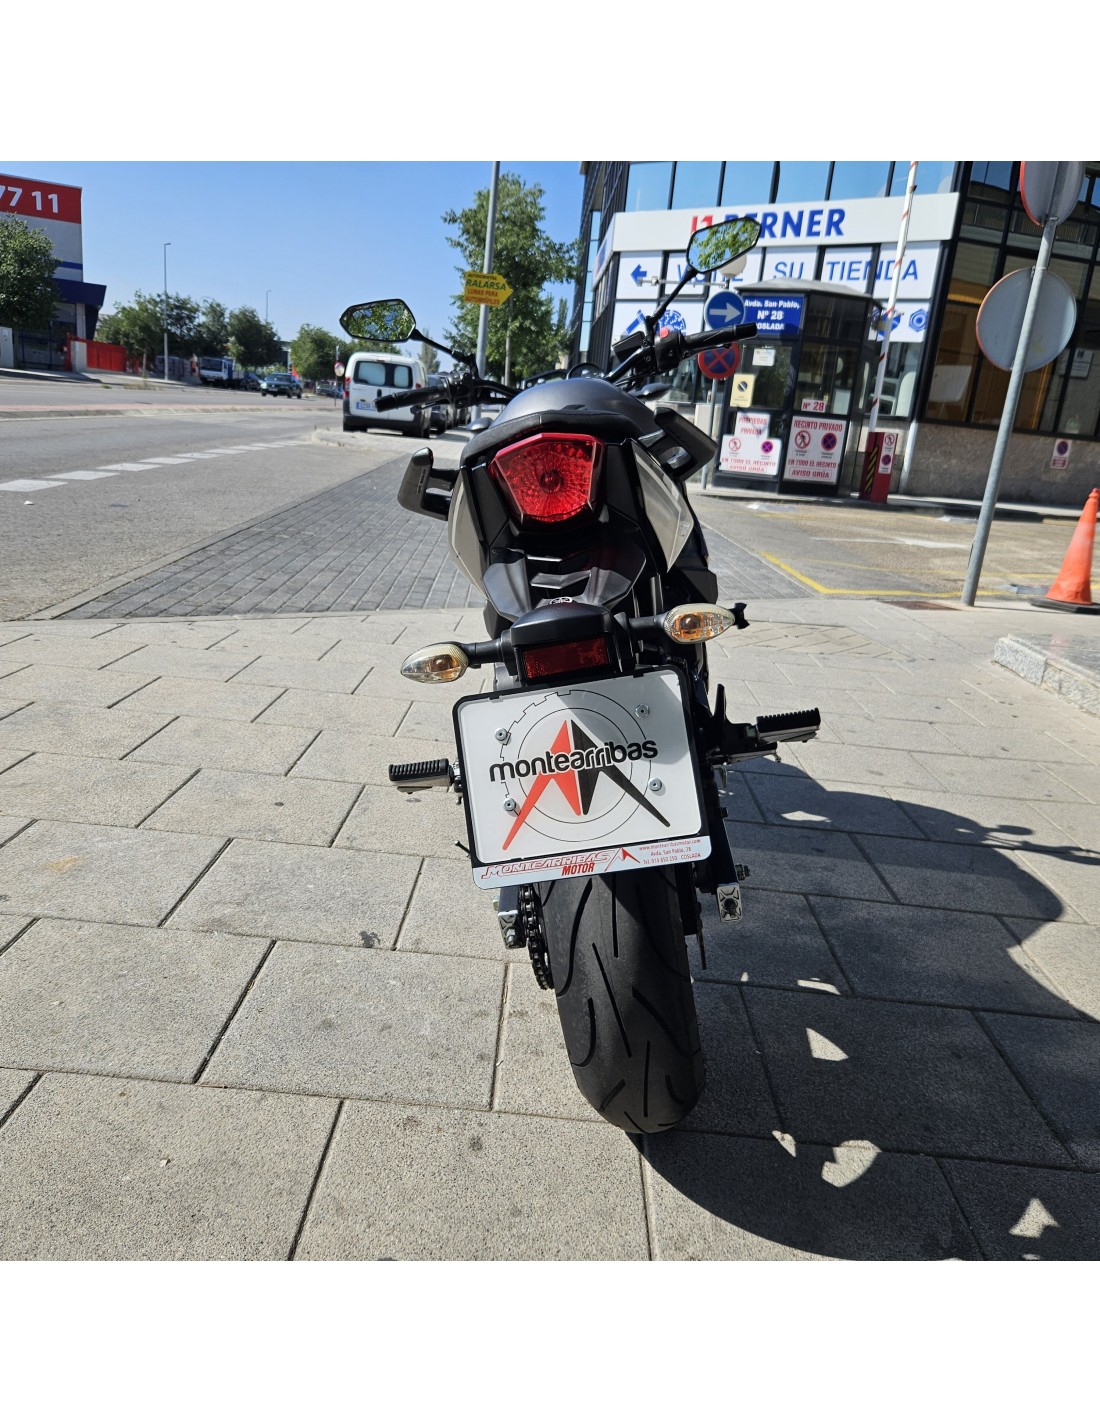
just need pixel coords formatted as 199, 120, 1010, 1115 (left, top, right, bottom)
296, 1102, 648, 1260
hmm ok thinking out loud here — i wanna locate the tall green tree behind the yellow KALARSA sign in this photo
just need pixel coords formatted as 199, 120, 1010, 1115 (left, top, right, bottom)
443, 173, 577, 380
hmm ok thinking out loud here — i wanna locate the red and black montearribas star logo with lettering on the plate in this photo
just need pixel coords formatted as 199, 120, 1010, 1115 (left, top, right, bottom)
489, 715, 669, 850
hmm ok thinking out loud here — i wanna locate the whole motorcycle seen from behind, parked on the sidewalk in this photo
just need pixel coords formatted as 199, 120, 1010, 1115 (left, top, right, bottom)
341, 219, 820, 1136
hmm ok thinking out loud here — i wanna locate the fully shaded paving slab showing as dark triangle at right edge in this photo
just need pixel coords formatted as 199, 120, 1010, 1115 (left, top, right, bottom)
982, 1012, 1100, 1170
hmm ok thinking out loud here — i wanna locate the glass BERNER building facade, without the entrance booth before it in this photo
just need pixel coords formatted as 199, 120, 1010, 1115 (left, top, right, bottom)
571, 159, 1100, 503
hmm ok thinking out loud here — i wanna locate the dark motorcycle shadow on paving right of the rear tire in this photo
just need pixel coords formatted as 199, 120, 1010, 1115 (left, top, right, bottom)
644, 766, 1100, 1260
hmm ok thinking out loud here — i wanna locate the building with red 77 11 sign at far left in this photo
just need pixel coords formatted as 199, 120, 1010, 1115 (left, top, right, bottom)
0, 173, 107, 370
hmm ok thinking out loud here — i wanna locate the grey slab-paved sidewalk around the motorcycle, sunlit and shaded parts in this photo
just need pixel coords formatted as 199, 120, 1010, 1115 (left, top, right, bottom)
0, 596, 1100, 1260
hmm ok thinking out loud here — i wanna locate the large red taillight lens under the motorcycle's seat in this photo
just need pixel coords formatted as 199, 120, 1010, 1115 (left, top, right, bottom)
489, 434, 604, 523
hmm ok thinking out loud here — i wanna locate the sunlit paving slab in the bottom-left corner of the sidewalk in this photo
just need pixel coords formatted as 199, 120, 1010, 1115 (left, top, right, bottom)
0, 1075, 337, 1260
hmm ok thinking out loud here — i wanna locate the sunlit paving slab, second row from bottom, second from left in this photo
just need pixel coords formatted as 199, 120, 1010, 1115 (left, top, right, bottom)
202, 943, 505, 1108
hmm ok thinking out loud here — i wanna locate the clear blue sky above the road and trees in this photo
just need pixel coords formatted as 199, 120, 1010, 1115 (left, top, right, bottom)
0, 158, 584, 358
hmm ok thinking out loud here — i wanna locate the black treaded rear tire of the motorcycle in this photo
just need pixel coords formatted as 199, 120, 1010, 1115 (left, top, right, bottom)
539, 869, 705, 1135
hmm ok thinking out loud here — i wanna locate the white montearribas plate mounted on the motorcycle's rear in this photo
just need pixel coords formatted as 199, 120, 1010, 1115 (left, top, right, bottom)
455, 667, 711, 889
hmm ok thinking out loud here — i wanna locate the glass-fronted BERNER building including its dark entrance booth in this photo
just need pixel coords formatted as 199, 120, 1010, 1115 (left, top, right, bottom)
571, 161, 1100, 506
